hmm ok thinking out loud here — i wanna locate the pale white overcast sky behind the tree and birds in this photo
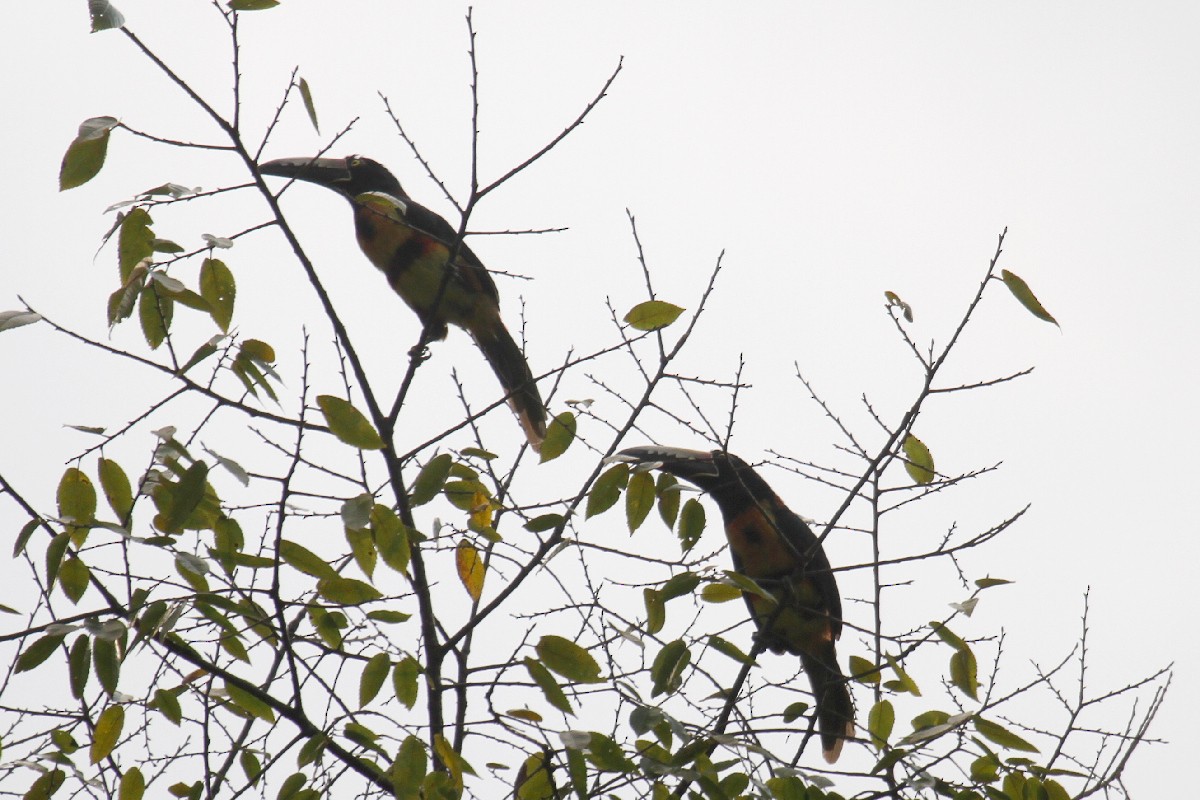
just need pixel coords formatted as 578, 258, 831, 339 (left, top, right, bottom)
0, 0, 1200, 796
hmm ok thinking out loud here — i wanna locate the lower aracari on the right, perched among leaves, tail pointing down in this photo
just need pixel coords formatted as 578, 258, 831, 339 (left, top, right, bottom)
618, 446, 854, 764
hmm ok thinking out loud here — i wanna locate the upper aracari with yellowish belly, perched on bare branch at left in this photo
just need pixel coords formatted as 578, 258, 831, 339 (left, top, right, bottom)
258, 156, 546, 450
